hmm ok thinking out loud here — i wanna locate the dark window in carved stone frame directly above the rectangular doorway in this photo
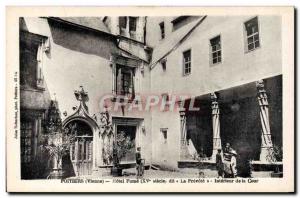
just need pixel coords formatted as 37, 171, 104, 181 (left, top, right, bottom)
116, 65, 134, 99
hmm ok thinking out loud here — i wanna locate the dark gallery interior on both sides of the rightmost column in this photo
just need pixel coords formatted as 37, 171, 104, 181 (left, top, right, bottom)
220, 76, 282, 176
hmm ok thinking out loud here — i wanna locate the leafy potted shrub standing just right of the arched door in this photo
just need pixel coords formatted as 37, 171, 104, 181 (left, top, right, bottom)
111, 131, 134, 177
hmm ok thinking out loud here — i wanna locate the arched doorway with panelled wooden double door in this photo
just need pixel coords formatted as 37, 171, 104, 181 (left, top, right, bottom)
65, 120, 93, 176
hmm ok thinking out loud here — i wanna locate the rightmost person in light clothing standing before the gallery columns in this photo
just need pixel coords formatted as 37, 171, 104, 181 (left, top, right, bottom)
223, 143, 237, 178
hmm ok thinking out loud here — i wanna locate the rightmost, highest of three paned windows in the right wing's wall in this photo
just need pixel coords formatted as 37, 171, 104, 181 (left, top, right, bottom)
245, 17, 260, 51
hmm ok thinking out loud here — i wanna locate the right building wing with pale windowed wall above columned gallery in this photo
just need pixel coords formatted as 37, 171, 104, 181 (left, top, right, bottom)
146, 16, 282, 173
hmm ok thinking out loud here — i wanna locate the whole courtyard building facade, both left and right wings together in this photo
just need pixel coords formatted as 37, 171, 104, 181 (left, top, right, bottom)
20, 16, 282, 178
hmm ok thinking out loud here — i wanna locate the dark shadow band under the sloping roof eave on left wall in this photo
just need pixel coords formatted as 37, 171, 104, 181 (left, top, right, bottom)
48, 19, 118, 60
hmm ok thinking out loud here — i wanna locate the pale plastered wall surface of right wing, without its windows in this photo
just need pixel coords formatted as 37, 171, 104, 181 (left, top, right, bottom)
148, 16, 282, 169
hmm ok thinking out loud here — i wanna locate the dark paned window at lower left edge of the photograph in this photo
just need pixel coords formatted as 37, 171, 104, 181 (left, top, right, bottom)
21, 121, 33, 164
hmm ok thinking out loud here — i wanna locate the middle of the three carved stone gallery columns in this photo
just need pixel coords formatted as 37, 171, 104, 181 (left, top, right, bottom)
210, 93, 222, 162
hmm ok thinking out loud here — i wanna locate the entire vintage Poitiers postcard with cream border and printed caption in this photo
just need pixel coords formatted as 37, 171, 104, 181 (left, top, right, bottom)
6, 7, 295, 192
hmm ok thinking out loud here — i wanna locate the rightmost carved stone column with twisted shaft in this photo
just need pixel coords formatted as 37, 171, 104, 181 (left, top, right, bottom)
256, 80, 273, 162
